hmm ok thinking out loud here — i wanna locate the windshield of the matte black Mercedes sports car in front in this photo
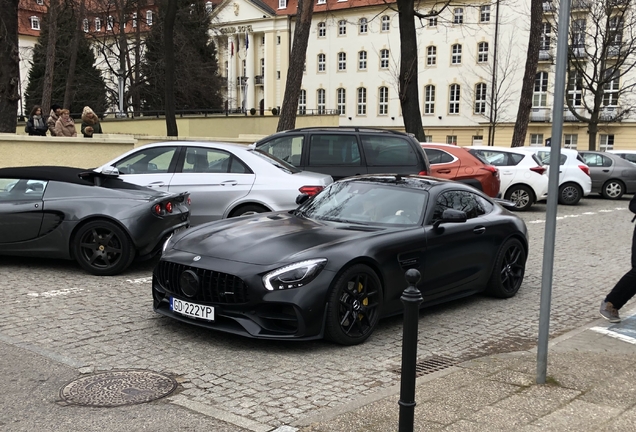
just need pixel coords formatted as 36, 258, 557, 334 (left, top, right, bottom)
298, 181, 428, 226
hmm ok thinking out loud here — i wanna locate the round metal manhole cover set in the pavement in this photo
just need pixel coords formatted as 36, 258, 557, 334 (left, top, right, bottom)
60, 370, 177, 407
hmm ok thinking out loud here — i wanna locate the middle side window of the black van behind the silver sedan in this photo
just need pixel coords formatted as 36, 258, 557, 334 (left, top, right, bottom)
309, 134, 361, 166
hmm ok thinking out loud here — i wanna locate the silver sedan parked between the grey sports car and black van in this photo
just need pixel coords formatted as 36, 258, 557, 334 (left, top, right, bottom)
97, 141, 333, 225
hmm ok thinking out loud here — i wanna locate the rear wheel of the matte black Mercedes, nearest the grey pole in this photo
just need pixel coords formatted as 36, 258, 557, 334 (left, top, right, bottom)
487, 238, 526, 298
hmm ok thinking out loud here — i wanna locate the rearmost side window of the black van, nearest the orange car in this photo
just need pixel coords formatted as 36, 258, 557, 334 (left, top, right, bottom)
360, 135, 418, 166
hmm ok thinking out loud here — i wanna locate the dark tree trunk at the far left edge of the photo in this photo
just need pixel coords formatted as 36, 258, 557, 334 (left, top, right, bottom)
0, 0, 20, 133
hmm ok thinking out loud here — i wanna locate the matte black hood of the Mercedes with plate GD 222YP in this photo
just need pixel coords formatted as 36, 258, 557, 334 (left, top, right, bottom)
173, 212, 386, 265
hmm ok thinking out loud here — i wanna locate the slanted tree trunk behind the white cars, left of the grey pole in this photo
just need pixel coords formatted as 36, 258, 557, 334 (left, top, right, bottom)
511, 0, 543, 147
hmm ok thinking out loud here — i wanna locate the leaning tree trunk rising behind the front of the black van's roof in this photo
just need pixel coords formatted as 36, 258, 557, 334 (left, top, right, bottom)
276, 0, 314, 132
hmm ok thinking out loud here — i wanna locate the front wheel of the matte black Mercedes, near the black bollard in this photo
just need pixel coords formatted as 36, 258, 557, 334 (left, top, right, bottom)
325, 264, 383, 345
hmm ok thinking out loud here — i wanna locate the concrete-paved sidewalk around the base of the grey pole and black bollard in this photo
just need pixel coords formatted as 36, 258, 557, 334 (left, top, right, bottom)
294, 310, 636, 432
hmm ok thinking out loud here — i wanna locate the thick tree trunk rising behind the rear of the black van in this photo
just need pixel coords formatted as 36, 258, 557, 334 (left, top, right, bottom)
397, 0, 425, 142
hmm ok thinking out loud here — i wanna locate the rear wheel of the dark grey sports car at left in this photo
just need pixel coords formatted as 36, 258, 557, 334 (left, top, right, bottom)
73, 220, 135, 276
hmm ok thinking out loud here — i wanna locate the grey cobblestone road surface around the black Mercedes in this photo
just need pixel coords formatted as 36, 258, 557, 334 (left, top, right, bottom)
0, 197, 633, 431
